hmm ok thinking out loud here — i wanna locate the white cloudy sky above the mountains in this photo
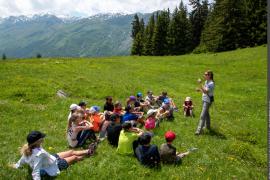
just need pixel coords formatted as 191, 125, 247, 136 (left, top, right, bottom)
0, 0, 192, 17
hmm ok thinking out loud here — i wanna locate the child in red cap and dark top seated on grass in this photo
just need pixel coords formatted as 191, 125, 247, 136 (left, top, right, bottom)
160, 131, 189, 164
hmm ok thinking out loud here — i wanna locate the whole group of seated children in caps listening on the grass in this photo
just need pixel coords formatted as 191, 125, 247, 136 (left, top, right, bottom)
12, 91, 193, 179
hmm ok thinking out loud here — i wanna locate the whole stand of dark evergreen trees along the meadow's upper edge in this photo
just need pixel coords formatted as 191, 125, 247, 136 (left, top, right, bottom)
131, 0, 267, 56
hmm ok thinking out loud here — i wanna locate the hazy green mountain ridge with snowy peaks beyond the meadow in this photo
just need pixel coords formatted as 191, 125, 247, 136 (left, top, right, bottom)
0, 13, 151, 58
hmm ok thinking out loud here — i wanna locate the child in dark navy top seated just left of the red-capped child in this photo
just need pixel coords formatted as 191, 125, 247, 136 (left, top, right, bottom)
135, 132, 160, 168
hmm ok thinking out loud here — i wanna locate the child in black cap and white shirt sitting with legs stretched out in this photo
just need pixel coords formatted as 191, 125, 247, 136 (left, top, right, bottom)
10, 131, 96, 180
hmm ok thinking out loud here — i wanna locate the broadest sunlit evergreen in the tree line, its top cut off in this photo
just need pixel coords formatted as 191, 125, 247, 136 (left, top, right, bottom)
201, 0, 248, 51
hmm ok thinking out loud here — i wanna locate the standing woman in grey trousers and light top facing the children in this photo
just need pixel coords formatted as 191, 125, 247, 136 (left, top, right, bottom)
195, 70, 215, 135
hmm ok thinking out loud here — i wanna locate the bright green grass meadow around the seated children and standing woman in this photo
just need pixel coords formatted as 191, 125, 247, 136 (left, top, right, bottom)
0, 47, 267, 180
